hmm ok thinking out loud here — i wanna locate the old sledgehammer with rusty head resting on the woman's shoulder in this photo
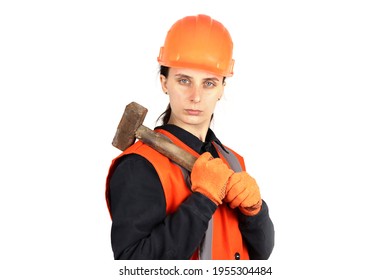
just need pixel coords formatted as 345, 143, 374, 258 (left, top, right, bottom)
112, 102, 196, 171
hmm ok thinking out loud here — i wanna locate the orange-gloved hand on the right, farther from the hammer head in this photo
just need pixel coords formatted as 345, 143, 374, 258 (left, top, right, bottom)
224, 171, 262, 216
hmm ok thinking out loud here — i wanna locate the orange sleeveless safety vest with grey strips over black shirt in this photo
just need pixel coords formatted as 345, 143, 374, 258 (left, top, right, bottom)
106, 129, 249, 260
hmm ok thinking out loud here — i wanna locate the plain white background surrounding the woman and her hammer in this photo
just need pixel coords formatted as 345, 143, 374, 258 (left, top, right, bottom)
0, 0, 390, 279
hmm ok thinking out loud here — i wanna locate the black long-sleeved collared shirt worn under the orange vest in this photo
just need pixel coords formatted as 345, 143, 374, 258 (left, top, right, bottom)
109, 125, 274, 259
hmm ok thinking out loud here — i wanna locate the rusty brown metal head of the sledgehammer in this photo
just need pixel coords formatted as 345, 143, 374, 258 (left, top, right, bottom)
112, 102, 148, 151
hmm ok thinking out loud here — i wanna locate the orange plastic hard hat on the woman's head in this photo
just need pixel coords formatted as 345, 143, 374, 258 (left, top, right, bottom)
157, 15, 234, 76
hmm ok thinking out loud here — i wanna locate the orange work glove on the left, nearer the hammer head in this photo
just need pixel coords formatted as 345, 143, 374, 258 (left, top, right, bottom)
191, 152, 234, 205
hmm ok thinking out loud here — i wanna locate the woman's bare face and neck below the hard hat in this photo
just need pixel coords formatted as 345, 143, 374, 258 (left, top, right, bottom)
160, 68, 224, 138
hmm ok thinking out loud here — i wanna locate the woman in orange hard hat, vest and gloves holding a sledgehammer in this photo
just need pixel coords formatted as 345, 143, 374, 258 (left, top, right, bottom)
106, 15, 274, 259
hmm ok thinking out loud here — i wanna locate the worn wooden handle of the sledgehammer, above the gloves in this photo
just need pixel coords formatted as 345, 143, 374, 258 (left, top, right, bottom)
135, 125, 197, 171
